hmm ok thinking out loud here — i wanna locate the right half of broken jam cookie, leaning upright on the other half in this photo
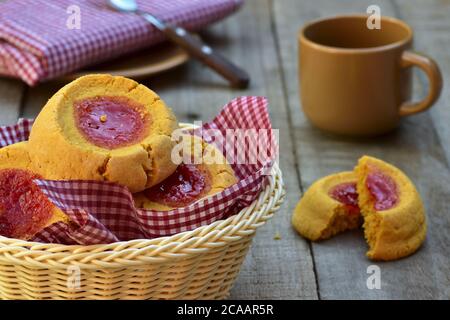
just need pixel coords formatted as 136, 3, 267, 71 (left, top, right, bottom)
355, 156, 427, 260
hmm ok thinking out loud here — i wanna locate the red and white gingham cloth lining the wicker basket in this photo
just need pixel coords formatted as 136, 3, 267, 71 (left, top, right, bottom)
0, 97, 278, 245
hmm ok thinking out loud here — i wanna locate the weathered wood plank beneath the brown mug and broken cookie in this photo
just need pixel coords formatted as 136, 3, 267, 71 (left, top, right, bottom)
274, 0, 450, 299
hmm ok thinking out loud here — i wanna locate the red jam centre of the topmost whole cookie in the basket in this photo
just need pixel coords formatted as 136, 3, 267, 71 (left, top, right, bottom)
74, 97, 148, 149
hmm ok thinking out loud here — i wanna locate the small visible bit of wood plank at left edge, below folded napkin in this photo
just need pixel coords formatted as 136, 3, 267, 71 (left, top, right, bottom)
0, 78, 25, 125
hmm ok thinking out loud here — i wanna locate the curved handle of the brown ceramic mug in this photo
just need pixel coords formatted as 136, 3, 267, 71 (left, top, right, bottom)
400, 51, 442, 117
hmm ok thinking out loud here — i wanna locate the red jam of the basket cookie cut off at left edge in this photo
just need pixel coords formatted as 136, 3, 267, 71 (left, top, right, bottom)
0, 169, 54, 240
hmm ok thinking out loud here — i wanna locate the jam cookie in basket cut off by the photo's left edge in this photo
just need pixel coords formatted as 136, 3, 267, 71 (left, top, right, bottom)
0, 142, 69, 240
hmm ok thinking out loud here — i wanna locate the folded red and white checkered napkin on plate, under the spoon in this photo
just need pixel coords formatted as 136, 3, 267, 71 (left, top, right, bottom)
0, 0, 243, 85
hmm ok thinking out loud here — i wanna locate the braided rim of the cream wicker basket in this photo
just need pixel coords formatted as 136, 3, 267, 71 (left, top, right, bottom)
0, 163, 285, 268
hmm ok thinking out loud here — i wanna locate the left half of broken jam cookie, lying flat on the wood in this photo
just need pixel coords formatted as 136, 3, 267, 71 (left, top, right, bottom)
292, 172, 362, 241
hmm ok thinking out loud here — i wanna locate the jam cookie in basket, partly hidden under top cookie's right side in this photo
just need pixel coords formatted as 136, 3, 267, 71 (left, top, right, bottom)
134, 136, 237, 211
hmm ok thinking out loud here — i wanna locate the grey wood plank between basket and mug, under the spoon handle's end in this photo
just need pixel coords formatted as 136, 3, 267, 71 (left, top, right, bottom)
19, 0, 317, 299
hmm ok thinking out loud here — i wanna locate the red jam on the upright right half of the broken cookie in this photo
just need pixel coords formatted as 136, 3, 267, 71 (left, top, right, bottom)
366, 171, 398, 211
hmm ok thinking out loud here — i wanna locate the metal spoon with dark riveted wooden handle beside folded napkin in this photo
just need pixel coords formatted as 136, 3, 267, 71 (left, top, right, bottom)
107, 0, 250, 89
